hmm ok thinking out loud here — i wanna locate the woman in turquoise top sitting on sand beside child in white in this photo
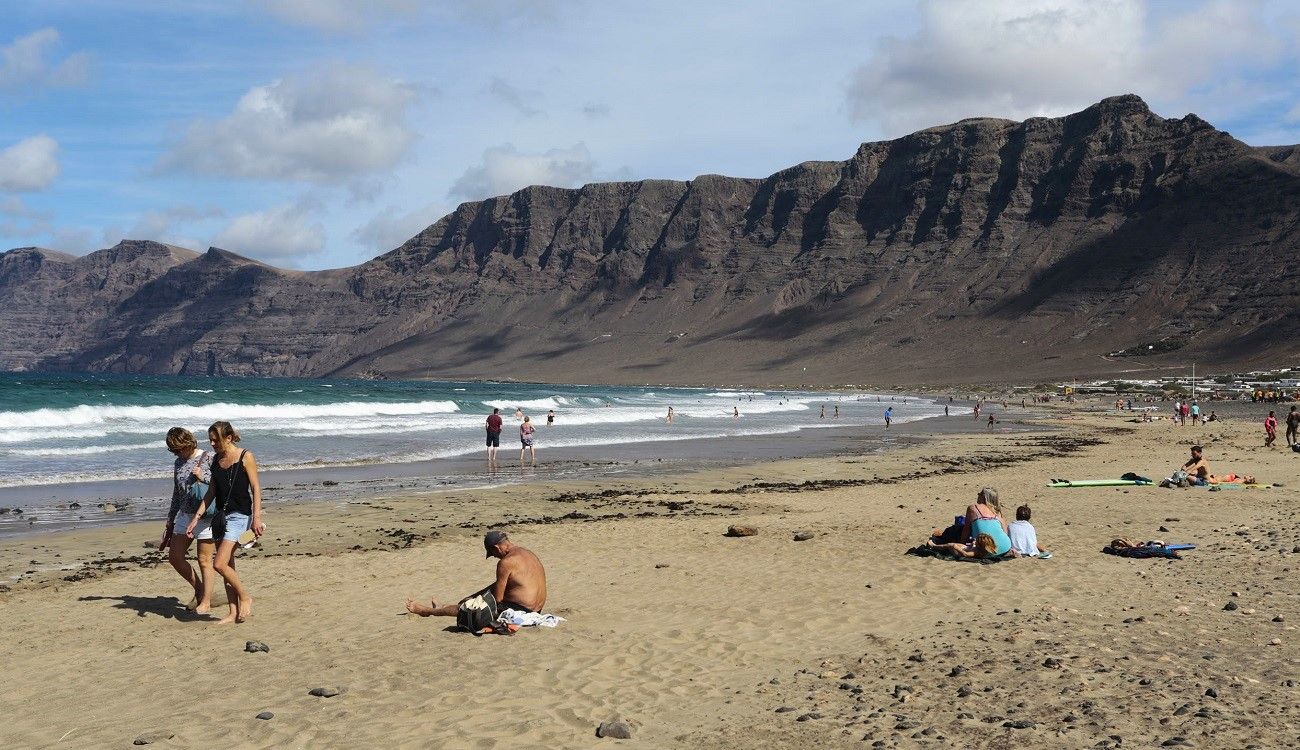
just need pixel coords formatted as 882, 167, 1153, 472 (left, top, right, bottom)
926, 487, 1052, 559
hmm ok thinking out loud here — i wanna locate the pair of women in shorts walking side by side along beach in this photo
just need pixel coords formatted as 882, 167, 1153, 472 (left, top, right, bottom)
159, 421, 267, 623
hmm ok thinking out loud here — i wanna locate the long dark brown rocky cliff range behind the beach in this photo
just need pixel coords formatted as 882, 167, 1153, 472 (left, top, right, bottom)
0, 96, 1300, 383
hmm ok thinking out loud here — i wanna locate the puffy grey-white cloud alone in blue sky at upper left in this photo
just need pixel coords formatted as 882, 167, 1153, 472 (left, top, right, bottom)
159, 65, 416, 183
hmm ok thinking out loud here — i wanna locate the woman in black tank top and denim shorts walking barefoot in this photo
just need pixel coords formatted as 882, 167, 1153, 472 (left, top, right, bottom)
185, 422, 267, 624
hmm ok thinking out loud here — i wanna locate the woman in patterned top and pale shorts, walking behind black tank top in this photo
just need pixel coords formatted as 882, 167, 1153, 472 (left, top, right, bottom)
159, 428, 217, 615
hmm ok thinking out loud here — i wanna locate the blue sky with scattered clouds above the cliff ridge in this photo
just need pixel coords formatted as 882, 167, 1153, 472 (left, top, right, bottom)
0, 0, 1300, 269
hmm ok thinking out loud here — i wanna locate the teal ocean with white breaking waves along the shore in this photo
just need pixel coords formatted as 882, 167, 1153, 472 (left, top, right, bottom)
0, 373, 966, 530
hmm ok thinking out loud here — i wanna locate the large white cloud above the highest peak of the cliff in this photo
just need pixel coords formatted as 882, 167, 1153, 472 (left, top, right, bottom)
848, 0, 1282, 135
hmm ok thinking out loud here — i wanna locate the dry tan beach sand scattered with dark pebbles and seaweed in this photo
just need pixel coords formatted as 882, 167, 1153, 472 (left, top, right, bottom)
0, 408, 1300, 749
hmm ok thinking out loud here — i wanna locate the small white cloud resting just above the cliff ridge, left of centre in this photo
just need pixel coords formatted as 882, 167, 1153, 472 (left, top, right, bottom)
451, 143, 595, 200
